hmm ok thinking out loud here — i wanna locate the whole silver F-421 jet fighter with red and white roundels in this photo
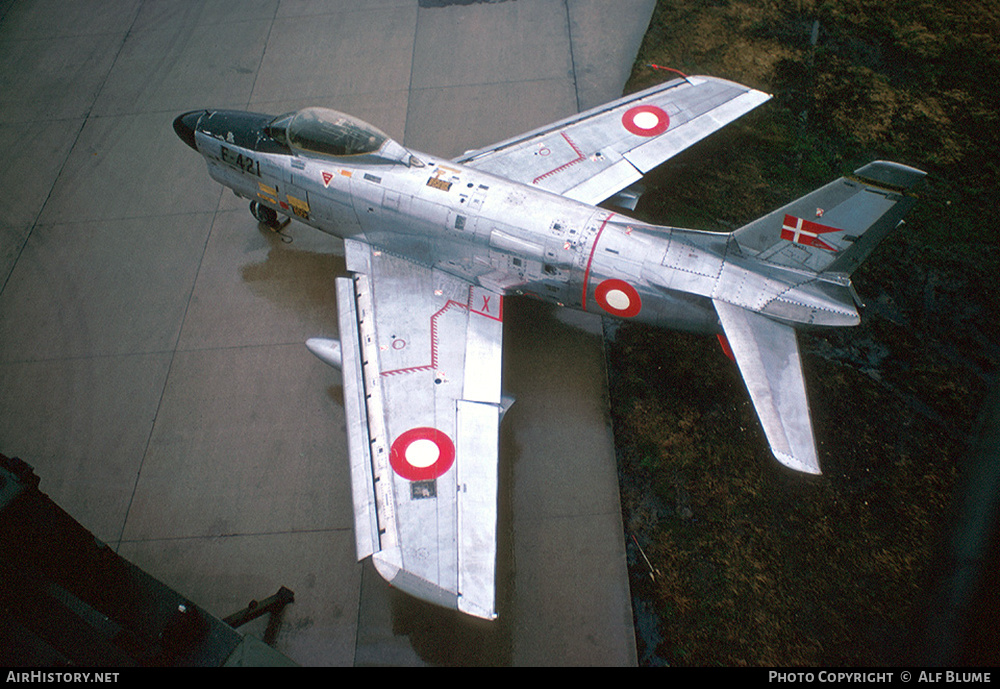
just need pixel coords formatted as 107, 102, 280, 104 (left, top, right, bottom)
174, 77, 924, 619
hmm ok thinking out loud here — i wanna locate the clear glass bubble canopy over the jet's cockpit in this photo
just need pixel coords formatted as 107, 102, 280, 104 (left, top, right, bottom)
265, 108, 389, 157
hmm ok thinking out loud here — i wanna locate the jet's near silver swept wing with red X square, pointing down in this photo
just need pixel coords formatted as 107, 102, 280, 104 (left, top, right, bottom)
324, 240, 503, 618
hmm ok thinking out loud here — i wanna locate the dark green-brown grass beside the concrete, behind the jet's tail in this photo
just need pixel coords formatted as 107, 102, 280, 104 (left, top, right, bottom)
609, 0, 1000, 666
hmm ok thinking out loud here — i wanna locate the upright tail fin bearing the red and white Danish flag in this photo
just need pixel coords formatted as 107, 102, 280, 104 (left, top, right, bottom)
733, 160, 925, 275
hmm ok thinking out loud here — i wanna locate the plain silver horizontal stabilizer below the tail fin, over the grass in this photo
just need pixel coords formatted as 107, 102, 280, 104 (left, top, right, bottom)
714, 300, 820, 474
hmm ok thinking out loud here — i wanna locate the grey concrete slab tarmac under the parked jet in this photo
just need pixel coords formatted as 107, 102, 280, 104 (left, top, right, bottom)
0, 0, 654, 666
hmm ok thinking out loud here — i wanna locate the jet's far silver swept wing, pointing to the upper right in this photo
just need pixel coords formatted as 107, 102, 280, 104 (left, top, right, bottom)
456, 77, 770, 204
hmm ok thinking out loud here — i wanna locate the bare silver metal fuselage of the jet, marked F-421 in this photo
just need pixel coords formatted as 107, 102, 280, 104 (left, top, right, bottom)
196, 125, 858, 340
